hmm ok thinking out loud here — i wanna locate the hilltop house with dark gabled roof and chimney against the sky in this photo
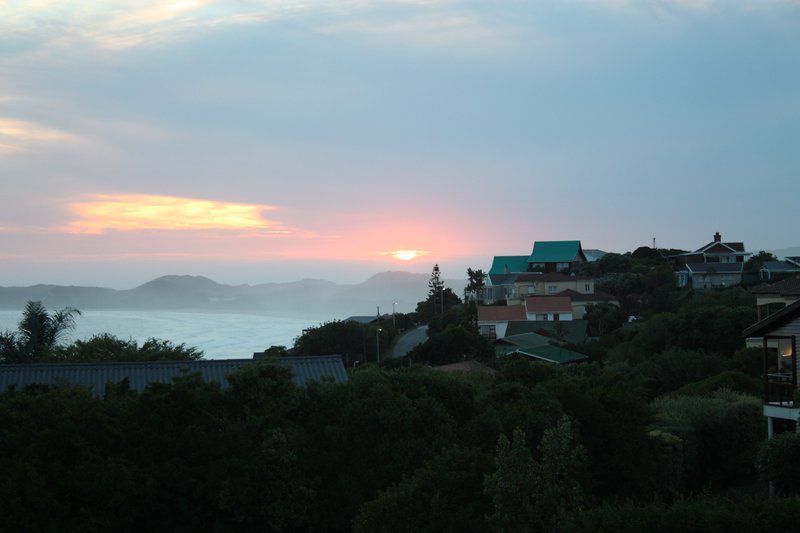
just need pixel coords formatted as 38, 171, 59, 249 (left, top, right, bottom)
671, 232, 750, 289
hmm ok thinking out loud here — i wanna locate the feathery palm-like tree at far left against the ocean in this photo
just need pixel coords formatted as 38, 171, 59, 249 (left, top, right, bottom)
0, 301, 81, 363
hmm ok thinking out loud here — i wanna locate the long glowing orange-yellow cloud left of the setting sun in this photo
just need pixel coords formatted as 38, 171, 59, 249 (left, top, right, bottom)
68, 194, 286, 233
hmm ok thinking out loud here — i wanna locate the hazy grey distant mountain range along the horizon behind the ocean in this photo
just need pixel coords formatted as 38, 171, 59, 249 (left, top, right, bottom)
0, 272, 466, 318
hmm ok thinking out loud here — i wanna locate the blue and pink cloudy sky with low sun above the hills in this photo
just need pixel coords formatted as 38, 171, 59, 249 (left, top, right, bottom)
0, 0, 800, 288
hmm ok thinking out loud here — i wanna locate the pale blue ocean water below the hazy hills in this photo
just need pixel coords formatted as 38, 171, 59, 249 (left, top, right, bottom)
0, 309, 326, 359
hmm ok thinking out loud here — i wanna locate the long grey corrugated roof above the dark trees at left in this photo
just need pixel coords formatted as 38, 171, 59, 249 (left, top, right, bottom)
0, 355, 347, 396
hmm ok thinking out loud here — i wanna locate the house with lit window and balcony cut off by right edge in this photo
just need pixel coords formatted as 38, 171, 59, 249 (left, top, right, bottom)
744, 300, 800, 438
